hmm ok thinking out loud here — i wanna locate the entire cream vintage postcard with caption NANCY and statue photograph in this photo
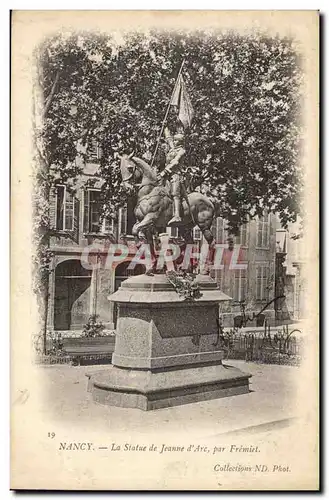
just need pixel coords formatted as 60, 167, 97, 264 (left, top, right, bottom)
11, 11, 319, 491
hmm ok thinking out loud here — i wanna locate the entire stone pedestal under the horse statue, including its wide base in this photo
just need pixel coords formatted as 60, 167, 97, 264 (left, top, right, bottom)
88, 275, 250, 410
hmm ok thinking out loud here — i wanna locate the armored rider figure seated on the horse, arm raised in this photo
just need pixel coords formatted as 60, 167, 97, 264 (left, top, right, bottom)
160, 128, 185, 226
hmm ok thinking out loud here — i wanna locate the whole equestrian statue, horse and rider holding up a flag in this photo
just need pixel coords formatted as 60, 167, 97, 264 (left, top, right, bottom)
119, 64, 215, 278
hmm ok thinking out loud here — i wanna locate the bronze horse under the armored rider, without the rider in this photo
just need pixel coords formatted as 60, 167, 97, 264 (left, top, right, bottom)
119, 153, 215, 270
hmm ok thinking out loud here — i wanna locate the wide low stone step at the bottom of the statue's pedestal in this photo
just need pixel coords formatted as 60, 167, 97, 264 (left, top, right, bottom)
88, 364, 250, 410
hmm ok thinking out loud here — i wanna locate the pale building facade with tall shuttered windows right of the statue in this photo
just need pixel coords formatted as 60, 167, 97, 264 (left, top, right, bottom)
212, 213, 277, 326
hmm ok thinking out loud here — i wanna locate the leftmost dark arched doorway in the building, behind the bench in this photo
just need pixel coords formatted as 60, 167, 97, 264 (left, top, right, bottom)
54, 259, 92, 330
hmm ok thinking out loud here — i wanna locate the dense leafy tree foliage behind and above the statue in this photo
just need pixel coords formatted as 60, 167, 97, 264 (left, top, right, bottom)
35, 31, 302, 231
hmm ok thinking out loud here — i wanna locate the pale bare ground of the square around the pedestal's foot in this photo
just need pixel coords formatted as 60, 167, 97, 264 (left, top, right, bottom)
37, 360, 299, 438
